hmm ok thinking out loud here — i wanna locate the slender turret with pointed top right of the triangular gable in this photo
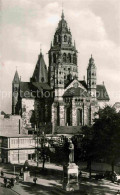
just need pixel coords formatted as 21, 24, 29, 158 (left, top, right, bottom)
87, 55, 97, 98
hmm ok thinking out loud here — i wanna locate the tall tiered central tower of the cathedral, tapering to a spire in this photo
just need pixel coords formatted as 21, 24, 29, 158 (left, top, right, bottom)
49, 11, 78, 88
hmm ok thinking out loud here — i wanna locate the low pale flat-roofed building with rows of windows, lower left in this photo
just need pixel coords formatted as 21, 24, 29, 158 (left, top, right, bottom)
0, 135, 36, 164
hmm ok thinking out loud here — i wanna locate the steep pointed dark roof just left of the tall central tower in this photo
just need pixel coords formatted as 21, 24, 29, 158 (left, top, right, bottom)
32, 53, 48, 83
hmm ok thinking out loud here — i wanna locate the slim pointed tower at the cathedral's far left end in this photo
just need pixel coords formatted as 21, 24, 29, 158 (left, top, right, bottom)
12, 70, 20, 115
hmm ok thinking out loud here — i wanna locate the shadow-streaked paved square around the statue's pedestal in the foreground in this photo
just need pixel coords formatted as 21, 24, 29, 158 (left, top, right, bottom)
0, 164, 120, 195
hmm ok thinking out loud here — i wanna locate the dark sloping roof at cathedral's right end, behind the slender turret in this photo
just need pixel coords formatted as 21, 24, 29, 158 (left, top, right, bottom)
96, 85, 110, 101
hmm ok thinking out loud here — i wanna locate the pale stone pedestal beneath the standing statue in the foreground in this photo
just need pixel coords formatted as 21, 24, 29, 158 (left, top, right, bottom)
63, 163, 79, 191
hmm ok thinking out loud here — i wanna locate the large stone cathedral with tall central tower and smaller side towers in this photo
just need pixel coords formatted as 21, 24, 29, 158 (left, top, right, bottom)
12, 11, 109, 134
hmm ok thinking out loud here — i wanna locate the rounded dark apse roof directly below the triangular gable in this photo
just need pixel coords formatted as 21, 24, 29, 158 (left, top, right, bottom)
63, 87, 88, 97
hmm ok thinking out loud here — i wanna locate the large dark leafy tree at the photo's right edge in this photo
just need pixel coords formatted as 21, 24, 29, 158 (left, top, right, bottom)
92, 106, 120, 172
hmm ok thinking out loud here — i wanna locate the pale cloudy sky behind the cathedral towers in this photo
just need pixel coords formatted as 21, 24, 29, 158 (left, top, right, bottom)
0, 0, 120, 113
